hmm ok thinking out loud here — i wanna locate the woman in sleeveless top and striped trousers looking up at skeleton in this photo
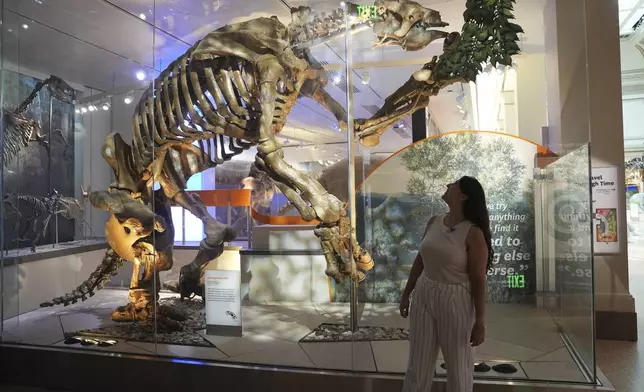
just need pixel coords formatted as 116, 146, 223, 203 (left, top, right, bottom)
400, 177, 493, 392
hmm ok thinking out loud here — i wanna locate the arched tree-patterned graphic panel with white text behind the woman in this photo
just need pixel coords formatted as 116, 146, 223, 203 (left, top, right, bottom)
335, 131, 547, 303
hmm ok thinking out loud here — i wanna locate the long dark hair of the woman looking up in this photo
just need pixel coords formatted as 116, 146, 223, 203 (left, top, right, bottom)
458, 176, 494, 270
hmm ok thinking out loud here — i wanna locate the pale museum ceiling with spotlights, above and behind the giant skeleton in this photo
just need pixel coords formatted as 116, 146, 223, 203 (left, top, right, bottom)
3, 0, 545, 161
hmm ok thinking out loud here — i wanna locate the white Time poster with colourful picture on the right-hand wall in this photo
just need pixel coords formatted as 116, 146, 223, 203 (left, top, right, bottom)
591, 166, 623, 254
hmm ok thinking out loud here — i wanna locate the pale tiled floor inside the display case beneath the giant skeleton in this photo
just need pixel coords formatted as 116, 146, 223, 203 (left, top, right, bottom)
4, 290, 582, 381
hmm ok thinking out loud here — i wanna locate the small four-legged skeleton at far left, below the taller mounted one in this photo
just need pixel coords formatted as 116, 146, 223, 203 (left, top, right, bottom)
3, 187, 95, 252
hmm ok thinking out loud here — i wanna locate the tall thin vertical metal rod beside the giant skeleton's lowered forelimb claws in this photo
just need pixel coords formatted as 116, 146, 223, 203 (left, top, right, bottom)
344, 13, 359, 332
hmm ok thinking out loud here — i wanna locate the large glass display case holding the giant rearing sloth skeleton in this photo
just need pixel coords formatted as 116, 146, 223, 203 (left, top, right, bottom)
1, 0, 595, 384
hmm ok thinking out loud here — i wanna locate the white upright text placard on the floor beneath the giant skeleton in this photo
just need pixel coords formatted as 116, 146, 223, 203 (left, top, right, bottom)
205, 269, 242, 336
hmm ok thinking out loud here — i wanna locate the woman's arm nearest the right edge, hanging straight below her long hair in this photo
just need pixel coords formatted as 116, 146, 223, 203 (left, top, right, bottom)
467, 226, 488, 323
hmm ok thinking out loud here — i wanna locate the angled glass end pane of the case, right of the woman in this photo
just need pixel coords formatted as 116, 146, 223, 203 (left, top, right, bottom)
543, 146, 599, 378
